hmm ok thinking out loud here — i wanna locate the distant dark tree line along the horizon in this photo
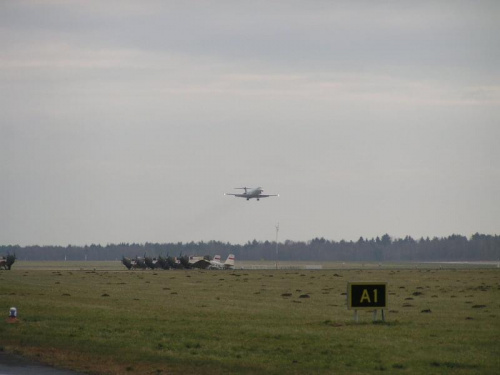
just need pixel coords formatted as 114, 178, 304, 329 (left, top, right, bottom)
0, 233, 500, 262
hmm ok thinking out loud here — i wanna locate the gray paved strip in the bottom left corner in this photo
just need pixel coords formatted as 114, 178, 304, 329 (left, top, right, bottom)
0, 352, 82, 375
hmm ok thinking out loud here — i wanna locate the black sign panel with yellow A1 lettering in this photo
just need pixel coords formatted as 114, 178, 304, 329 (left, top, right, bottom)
347, 282, 387, 310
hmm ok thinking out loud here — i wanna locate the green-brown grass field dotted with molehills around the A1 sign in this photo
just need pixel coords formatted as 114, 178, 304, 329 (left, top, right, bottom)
0, 262, 500, 374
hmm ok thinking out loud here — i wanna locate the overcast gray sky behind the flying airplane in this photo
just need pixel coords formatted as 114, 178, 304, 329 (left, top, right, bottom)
0, 0, 500, 245
